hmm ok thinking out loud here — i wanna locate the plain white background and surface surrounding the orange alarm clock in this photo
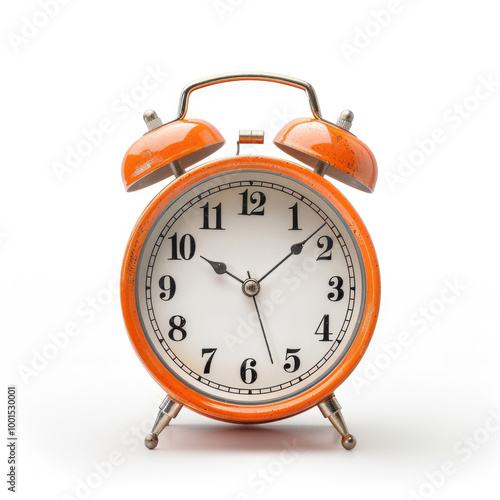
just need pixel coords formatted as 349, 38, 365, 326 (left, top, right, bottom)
0, 0, 500, 500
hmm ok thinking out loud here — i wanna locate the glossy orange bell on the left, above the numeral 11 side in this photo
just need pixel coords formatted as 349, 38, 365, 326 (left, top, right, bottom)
122, 119, 225, 191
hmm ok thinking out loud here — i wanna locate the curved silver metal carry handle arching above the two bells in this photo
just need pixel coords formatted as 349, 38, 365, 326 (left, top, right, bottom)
177, 73, 322, 120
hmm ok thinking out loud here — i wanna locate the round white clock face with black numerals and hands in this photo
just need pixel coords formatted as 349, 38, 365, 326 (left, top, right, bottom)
135, 169, 366, 405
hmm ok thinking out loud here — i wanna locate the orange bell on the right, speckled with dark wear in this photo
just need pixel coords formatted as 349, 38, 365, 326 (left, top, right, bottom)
274, 118, 378, 193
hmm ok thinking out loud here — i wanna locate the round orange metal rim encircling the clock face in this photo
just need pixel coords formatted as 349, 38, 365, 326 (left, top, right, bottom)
121, 156, 380, 423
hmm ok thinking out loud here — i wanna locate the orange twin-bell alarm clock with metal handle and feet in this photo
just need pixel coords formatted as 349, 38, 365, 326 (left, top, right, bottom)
121, 73, 380, 449
